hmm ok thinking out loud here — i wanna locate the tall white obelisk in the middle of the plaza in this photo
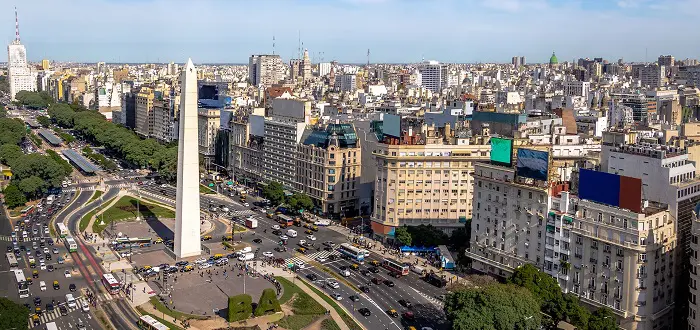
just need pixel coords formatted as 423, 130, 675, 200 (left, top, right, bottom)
175, 59, 202, 258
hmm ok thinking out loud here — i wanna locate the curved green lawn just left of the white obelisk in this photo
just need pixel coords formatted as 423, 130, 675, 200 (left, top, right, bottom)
93, 196, 175, 233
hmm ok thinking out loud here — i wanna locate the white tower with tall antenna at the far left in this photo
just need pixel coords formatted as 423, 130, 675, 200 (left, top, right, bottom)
7, 8, 36, 101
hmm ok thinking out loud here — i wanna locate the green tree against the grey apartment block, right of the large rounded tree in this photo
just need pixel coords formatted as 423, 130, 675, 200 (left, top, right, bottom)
508, 264, 565, 321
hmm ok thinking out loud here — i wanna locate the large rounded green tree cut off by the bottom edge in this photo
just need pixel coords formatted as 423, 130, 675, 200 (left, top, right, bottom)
444, 284, 542, 330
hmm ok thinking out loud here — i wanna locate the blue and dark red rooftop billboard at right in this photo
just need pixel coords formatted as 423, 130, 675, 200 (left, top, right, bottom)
578, 169, 642, 213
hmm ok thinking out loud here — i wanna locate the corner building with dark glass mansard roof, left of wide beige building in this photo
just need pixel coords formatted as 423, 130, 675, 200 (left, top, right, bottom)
296, 123, 362, 217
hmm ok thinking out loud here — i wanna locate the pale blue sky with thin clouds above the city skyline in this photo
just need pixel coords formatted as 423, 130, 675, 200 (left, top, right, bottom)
5, 0, 700, 63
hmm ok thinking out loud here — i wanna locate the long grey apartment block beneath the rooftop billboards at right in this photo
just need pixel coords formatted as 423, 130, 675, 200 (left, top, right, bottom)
466, 163, 677, 329
